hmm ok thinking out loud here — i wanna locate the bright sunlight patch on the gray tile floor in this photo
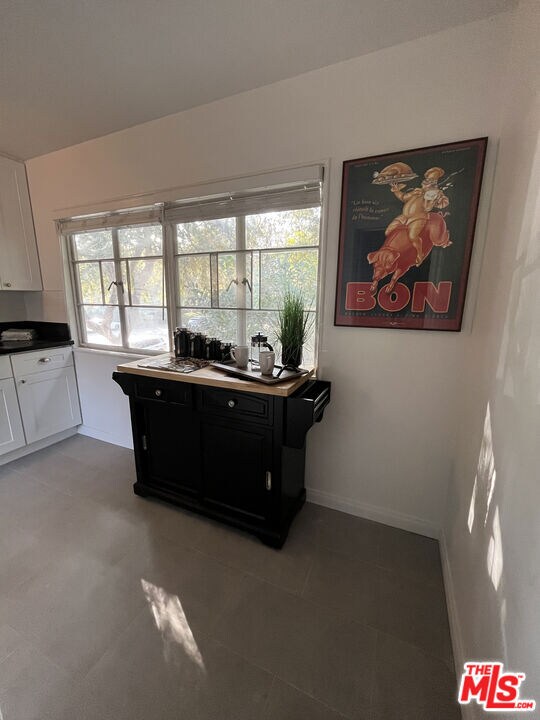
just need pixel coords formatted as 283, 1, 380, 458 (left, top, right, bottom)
140, 578, 206, 672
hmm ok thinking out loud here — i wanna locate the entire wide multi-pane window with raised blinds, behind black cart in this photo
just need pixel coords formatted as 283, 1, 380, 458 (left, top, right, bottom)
63, 166, 321, 364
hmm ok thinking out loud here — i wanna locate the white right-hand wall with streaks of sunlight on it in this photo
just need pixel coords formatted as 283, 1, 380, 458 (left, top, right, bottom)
445, 2, 540, 718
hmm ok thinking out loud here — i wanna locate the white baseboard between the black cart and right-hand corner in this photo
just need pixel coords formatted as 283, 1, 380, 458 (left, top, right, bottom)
307, 488, 440, 540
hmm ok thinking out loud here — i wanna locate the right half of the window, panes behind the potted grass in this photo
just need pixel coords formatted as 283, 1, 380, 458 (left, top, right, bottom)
175, 206, 320, 362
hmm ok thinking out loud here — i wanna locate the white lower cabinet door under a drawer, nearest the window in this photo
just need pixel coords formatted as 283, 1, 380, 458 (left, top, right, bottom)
17, 367, 81, 443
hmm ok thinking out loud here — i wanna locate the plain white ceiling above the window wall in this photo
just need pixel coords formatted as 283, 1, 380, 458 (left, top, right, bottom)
0, 0, 514, 159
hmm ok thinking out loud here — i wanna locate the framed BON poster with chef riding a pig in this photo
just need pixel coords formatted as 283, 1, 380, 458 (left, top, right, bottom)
335, 138, 487, 331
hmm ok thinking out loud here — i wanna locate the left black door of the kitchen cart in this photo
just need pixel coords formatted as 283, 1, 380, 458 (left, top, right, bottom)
138, 401, 201, 495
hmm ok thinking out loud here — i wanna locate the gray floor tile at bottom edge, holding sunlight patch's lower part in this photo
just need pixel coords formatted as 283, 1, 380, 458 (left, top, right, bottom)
59, 606, 272, 720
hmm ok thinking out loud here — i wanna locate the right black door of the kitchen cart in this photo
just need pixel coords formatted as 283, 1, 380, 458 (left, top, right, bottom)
201, 418, 272, 520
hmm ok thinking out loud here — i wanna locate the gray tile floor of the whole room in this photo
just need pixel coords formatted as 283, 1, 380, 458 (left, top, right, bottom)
0, 435, 460, 720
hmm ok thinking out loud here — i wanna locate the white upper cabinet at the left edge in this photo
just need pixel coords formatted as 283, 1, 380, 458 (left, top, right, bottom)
0, 157, 43, 290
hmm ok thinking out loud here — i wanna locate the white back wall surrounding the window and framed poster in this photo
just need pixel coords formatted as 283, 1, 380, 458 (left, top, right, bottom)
27, 14, 509, 534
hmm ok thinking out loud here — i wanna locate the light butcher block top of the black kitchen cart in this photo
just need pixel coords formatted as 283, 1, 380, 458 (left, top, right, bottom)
116, 356, 313, 397
